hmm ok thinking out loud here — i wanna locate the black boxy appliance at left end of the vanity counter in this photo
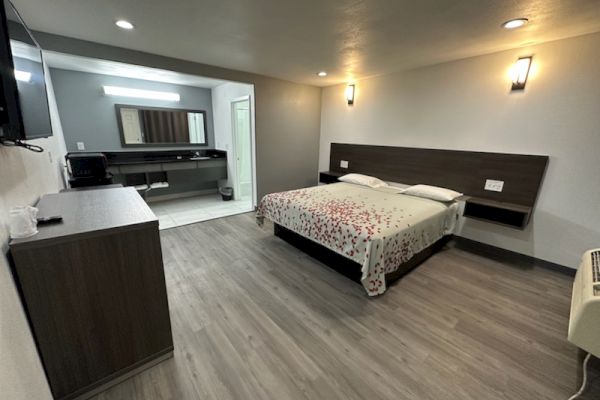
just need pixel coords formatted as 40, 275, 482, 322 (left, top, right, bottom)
65, 153, 112, 188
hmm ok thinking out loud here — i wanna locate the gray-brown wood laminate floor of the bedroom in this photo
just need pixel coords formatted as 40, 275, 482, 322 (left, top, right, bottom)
91, 213, 600, 400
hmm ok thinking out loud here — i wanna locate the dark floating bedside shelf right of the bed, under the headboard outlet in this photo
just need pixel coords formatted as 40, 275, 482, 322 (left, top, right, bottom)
463, 197, 533, 229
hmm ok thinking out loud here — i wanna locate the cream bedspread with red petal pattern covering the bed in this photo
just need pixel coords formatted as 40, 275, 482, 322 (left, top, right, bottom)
257, 182, 458, 296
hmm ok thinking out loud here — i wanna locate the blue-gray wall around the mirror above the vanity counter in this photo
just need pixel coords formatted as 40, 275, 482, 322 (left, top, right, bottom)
50, 68, 215, 151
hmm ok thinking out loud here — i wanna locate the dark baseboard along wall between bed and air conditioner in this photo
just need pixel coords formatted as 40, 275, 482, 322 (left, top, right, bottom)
450, 235, 577, 276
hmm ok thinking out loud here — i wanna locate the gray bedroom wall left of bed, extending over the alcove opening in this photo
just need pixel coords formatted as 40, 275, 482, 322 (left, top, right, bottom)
35, 32, 321, 199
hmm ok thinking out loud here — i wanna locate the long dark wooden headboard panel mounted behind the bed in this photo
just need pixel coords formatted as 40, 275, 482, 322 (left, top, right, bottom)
329, 143, 548, 207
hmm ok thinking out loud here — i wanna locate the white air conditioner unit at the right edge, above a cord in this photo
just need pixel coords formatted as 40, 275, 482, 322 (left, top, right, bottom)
568, 249, 600, 357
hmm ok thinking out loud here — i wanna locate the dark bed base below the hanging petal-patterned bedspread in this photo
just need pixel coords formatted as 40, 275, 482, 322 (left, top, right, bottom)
273, 224, 451, 285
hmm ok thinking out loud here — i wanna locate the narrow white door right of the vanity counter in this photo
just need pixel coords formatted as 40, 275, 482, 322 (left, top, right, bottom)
231, 99, 252, 201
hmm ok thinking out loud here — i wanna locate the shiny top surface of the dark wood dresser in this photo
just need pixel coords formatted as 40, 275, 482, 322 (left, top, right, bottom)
10, 187, 157, 249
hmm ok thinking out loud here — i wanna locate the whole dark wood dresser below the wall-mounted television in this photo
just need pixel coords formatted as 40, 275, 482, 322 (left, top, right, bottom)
10, 188, 173, 399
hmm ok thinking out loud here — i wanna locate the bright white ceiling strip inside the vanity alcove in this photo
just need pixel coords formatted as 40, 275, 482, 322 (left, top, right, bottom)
44, 51, 228, 89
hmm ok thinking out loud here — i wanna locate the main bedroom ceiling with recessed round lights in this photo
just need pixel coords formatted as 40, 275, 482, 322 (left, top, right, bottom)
13, 0, 600, 86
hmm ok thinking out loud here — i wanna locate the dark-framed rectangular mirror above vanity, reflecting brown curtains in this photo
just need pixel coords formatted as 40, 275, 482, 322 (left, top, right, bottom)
116, 104, 207, 146
